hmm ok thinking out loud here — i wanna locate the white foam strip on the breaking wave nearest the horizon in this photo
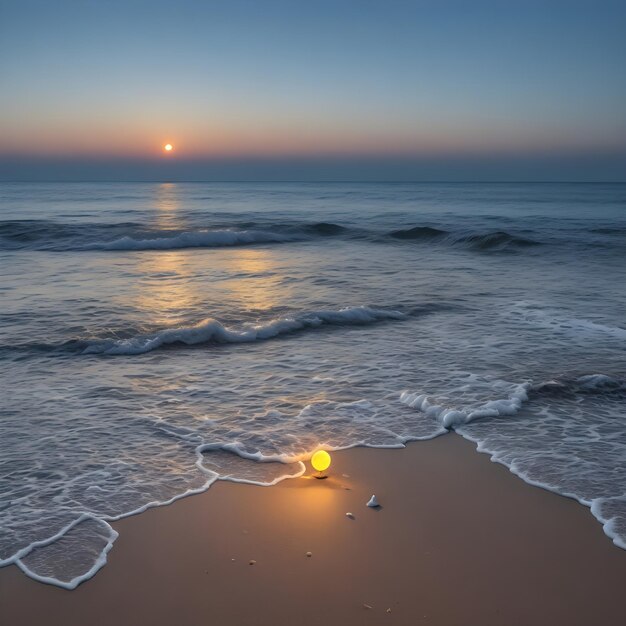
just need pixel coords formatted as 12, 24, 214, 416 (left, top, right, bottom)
84, 229, 294, 251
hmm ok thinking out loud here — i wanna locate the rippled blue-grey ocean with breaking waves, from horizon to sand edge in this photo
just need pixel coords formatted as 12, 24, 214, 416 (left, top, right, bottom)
0, 183, 626, 588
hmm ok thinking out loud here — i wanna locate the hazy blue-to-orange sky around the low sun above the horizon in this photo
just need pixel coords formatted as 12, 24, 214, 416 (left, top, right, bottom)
0, 0, 626, 181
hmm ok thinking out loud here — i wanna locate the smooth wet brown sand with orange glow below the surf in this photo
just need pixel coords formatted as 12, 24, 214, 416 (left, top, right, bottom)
0, 434, 626, 626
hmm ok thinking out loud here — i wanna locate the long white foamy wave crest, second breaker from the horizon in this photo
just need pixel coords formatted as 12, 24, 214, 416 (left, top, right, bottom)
82, 306, 406, 355
